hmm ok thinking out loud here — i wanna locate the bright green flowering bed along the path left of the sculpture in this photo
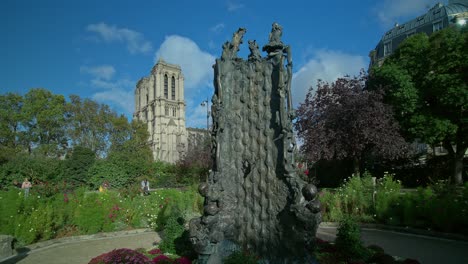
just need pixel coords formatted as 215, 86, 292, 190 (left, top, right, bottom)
0, 186, 201, 245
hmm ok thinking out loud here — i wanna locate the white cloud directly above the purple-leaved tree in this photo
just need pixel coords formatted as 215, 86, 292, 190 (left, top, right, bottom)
292, 50, 367, 106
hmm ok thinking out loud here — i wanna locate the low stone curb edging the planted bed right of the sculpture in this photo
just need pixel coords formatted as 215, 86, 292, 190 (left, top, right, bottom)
319, 222, 468, 242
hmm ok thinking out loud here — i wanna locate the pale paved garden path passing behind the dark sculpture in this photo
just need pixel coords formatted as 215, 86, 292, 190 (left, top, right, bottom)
1, 226, 468, 264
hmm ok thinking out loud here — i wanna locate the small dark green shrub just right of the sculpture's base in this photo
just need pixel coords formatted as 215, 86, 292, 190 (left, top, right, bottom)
335, 217, 370, 260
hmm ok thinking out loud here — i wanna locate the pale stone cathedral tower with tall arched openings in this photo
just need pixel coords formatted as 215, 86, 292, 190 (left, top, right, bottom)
133, 59, 187, 163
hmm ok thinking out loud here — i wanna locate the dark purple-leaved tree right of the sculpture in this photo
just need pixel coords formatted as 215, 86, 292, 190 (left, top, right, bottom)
295, 72, 407, 173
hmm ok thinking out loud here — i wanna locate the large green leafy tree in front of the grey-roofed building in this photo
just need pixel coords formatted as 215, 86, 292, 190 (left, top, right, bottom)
369, 27, 468, 184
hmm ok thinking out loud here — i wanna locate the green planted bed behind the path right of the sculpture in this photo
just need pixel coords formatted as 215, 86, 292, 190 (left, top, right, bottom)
319, 171, 468, 234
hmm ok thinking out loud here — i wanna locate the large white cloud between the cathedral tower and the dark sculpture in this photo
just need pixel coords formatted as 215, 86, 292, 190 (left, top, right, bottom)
155, 35, 215, 93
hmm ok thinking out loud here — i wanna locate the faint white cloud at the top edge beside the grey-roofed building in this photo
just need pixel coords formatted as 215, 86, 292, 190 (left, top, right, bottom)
375, 0, 440, 26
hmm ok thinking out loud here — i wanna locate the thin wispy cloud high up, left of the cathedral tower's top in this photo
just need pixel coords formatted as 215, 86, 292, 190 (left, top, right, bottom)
86, 22, 153, 54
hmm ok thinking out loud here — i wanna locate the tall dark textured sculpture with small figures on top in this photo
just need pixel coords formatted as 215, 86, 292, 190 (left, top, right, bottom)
190, 23, 321, 264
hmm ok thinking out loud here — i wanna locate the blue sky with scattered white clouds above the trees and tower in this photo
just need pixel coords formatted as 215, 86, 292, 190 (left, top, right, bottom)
0, 0, 446, 127
